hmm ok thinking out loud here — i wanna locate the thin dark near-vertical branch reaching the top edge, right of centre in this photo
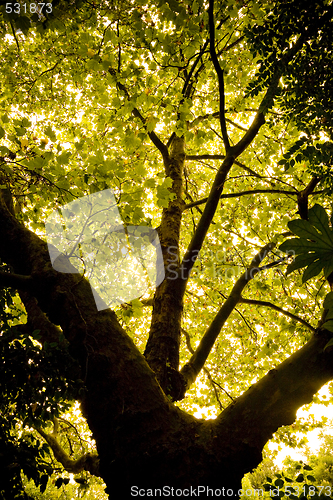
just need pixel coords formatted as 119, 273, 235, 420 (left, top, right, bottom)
208, 0, 230, 153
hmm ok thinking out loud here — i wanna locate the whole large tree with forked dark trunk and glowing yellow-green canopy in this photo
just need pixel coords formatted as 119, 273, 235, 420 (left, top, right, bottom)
0, 0, 333, 496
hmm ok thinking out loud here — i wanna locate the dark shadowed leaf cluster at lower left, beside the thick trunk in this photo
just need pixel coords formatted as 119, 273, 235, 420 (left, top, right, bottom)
0, 282, 82, 499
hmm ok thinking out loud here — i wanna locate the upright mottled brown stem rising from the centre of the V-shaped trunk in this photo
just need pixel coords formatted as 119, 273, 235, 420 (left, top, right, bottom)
145, 136, 185, 400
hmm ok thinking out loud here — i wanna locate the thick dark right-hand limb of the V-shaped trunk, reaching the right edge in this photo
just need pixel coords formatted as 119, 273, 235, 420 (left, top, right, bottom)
214, 330, 333, 470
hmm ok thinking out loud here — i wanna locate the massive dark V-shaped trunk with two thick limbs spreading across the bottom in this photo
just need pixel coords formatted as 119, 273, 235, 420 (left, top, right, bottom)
0, 198, 333, 498
